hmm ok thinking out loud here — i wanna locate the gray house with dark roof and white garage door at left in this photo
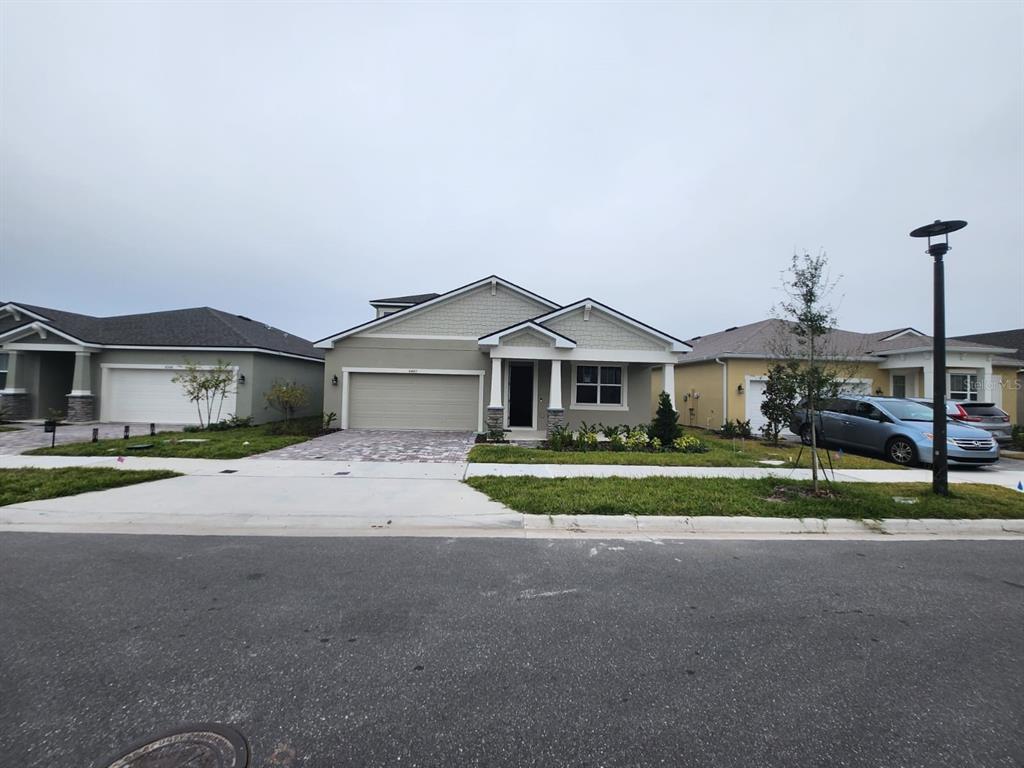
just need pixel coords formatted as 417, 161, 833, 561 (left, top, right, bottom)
0, 302, 324, 424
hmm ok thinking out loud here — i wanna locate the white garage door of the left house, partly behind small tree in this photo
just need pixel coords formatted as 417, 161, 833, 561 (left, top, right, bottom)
100, 368, 236, 424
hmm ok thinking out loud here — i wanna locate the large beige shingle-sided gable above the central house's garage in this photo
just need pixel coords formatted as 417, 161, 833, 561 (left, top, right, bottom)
361, 285, 550, 338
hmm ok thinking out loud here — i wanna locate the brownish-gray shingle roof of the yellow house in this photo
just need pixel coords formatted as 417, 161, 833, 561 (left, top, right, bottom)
684, 318, 1005, 362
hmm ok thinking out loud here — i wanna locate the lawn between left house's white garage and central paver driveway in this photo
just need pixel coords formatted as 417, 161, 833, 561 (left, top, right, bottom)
26, 424, 309, 459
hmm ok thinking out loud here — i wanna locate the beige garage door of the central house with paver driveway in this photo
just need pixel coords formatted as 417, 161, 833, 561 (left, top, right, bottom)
348, 373, 481, 432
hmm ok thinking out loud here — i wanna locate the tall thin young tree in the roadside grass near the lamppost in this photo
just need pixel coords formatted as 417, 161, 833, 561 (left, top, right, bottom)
777, 252, 849, 494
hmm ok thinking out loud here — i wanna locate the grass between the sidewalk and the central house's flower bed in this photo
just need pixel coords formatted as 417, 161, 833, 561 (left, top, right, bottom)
469, 431, 900, 470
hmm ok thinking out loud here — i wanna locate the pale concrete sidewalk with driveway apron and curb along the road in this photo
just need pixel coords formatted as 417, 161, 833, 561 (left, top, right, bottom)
0, 456, 1024, 540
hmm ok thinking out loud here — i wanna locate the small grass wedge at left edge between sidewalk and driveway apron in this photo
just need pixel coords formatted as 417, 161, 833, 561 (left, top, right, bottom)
0, 467, 179, 507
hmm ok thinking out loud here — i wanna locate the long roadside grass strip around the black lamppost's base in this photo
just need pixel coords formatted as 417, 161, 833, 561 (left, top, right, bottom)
466, 475, 1024, 519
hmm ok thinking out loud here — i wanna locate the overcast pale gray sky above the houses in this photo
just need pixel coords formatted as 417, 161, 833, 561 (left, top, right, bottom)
0, 2, 1024, 339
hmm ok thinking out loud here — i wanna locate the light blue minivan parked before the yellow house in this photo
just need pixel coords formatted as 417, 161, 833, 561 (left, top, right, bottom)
790, 395, 999, 466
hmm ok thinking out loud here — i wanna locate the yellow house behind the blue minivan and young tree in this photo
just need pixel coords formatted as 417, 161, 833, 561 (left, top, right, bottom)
651, 319, 1020, 431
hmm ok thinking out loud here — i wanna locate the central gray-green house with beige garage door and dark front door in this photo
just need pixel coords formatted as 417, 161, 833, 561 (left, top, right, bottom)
316, 275, 690, 439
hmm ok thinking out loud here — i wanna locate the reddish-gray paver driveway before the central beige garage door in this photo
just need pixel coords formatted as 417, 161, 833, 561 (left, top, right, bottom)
254, 429, 476, 462
